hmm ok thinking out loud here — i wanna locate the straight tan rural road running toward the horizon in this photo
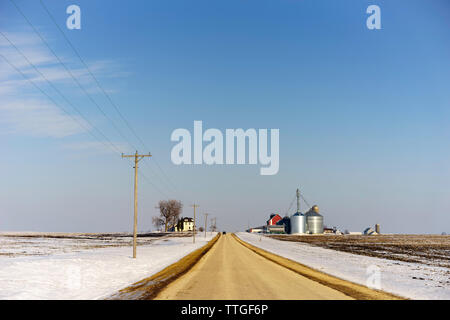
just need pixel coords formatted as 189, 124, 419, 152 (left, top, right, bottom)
156, 234, 351, 300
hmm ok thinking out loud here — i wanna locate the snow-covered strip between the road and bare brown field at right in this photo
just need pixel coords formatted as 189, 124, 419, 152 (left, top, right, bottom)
236, 232, 450, 299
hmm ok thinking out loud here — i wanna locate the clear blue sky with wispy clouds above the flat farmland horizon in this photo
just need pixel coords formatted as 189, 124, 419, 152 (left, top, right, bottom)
0, 0, 450, 233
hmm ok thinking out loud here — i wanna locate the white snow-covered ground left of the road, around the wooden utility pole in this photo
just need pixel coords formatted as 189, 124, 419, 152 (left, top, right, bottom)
0, 232, 216, 299
